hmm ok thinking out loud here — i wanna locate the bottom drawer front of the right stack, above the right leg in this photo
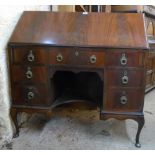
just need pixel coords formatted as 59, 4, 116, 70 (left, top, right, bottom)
103, 89, 144, 112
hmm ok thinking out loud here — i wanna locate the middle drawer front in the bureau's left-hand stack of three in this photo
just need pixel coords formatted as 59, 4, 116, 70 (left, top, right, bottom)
11, 65, 47, 83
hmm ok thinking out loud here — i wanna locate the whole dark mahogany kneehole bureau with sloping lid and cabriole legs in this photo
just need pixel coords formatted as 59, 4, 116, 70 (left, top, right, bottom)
8, 11, 148, 147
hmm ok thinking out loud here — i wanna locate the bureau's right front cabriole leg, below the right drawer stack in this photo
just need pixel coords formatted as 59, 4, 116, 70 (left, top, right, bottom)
135, 116, 145, 148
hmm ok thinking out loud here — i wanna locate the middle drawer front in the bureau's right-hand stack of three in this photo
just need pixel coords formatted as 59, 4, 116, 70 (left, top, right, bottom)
105, 69, 144, 87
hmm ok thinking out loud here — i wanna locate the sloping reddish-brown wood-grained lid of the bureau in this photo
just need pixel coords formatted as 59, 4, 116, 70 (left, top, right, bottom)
9, 11, 148, 49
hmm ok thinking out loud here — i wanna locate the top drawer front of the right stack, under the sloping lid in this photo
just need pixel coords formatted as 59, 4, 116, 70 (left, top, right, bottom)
106, 50, 144, 67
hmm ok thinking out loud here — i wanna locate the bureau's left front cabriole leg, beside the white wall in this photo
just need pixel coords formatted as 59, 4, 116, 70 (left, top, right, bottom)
11, 108, 19, 138
